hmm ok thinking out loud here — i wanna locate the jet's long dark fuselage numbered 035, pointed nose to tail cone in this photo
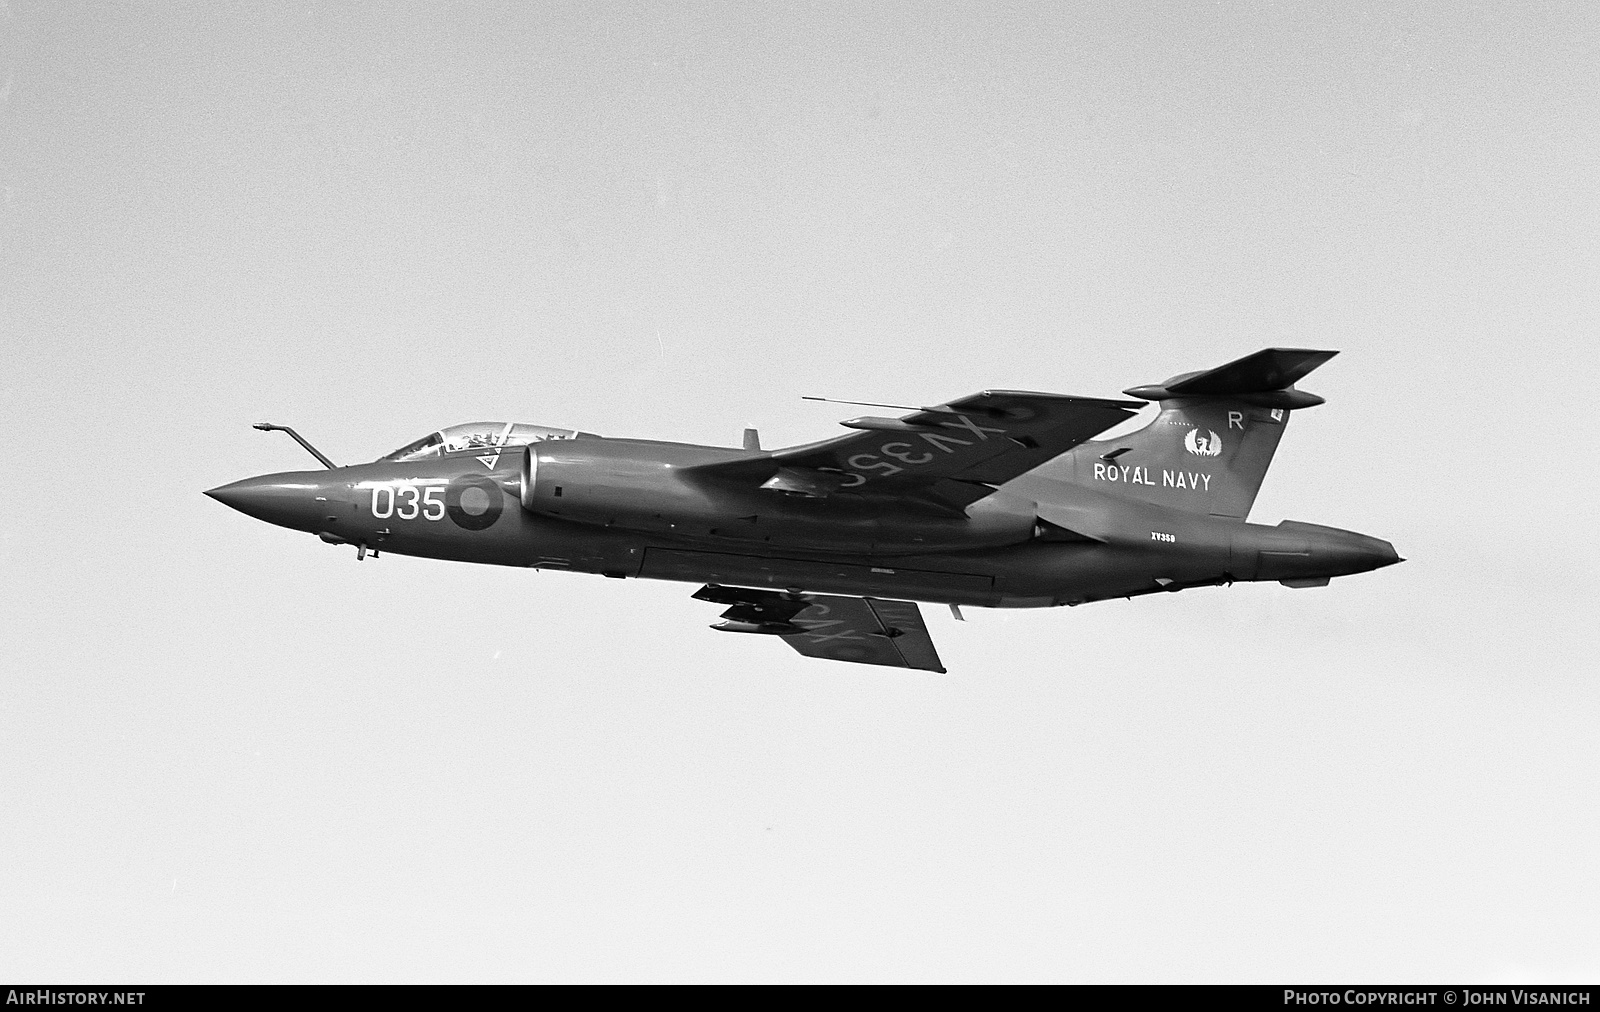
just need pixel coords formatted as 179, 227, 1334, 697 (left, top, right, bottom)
208, 437, 1398, 607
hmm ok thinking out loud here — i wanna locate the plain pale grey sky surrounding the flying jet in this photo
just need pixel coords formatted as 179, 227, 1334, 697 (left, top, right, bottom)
0, 0, 1600, 982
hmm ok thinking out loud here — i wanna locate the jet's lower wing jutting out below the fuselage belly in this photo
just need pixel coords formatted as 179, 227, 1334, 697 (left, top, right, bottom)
694, 586, 944, 674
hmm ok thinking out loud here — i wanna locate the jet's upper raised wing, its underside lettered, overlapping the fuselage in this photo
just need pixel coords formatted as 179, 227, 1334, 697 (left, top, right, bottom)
696, 391, 1144, 509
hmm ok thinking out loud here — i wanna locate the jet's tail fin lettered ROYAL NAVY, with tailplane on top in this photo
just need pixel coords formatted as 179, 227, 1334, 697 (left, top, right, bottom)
1040, 347, 1339, 520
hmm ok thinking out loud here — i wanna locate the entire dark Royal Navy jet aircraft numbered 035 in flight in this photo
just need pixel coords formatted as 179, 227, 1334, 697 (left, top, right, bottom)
206, 347, 1400, 671
